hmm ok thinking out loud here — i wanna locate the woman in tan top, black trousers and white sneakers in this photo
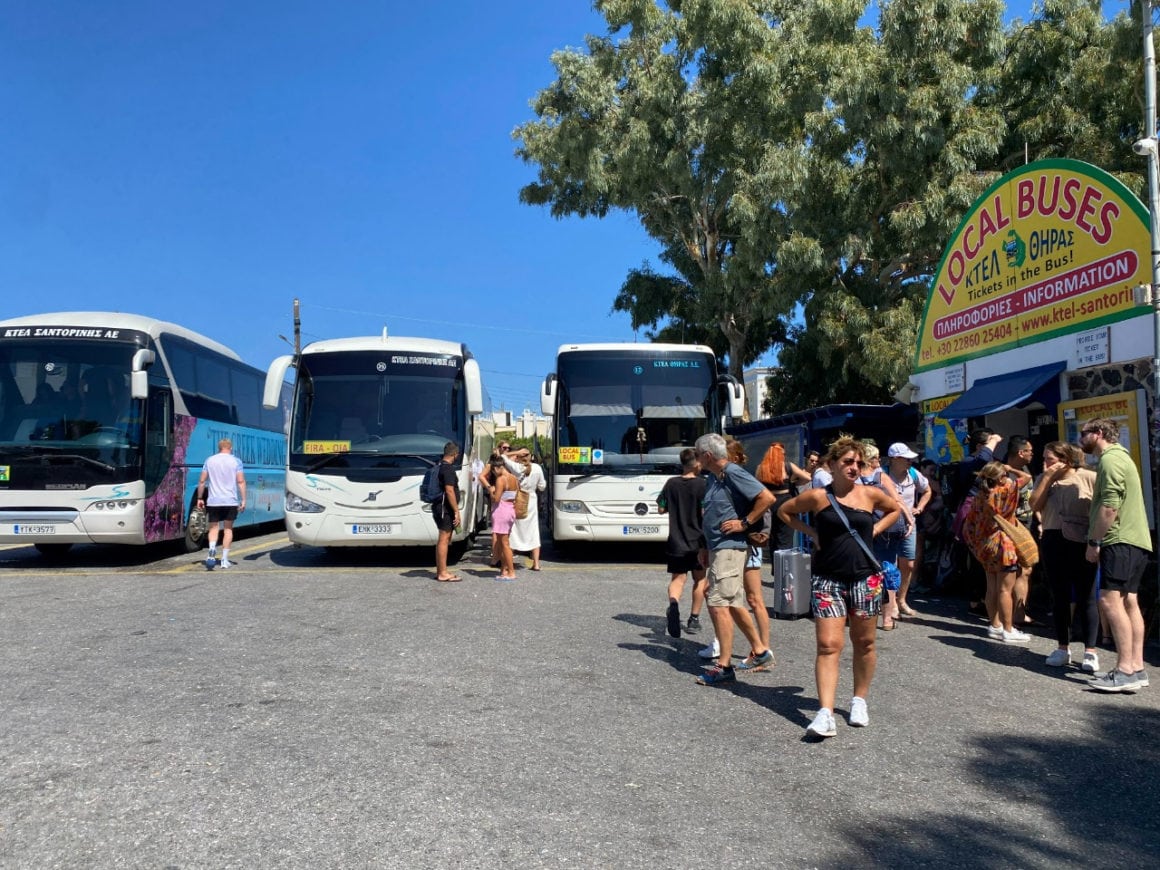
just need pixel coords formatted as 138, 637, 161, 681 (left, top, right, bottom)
1031, 441, 1100, 674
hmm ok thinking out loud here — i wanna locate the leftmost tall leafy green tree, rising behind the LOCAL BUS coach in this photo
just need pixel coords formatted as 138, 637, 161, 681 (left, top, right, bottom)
514, 0, 806, 412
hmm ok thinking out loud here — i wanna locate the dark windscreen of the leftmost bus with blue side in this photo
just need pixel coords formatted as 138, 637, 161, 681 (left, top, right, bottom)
0, 339, 143, 484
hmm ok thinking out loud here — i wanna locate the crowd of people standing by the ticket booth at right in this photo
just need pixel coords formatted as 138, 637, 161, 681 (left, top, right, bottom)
658, 419, 1152, 738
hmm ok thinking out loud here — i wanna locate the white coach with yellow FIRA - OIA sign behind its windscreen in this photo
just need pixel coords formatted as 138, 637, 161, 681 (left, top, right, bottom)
266, 329, 495, 558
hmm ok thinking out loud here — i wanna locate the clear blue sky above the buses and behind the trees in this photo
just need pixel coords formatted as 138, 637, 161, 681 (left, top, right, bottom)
0, 0, 1126, 412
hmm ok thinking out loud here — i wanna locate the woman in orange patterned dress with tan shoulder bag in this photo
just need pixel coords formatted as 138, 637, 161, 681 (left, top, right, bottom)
963, 462, 1031, 644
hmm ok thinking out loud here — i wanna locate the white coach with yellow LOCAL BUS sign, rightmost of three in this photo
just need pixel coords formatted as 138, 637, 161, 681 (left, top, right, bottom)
539, 343, 745, 541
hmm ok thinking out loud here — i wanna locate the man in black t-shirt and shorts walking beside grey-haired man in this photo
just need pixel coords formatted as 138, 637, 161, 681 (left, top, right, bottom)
657, 447, 709, 637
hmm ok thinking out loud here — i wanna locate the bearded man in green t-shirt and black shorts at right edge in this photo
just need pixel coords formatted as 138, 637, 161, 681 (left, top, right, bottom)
1080, 418, 1152, 691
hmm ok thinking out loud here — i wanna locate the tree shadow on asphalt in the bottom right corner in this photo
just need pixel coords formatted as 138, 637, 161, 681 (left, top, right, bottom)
827, 703, 1160, 868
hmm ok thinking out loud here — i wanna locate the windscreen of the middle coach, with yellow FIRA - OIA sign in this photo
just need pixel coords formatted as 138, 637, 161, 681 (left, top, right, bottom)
290, 351, 467, 471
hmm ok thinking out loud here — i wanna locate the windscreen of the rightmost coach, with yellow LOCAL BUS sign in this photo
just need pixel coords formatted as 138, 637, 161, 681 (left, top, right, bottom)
556, 350, 720, 473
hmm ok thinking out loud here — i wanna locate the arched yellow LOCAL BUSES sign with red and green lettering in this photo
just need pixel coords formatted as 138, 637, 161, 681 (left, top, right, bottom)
914, 160, 1152, 371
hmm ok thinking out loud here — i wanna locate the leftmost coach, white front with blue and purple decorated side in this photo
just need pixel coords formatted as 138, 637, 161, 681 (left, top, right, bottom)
0, 312, 289, 553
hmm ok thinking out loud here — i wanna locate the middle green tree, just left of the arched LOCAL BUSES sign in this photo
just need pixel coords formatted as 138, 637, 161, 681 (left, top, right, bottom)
771, 0, 1006, 411
